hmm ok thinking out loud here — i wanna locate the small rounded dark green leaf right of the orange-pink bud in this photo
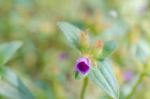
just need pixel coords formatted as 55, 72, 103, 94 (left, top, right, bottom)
99, 41, 117, 61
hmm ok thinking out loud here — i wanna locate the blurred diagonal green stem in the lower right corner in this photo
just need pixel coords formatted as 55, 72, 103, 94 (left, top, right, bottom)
126, 71, 145, 99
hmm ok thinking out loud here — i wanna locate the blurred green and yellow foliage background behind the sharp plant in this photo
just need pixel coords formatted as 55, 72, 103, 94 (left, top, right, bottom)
0, 0, 150, 99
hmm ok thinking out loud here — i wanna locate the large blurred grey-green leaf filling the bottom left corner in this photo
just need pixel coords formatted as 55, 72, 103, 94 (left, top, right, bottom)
0, 67, 35, 99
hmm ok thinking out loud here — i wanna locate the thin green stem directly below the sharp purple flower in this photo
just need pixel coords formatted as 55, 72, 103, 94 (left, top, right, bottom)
80, 77, 88, 99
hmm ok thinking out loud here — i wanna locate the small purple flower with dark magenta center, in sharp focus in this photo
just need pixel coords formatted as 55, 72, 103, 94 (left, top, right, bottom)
75, 57, 91, 75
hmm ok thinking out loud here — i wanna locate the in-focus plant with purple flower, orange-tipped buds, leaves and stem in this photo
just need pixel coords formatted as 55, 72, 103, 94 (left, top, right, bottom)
58, 22, 119, 99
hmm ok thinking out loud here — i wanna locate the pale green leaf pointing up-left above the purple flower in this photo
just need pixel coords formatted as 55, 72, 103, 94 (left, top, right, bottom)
58, 22, 81, 49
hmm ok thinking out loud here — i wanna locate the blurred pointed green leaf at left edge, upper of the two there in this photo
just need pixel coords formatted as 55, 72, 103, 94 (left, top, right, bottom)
0, 41, 22, 65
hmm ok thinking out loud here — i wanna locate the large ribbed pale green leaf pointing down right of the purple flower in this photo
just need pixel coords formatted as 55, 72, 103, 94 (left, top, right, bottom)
89, 61, 119, 99
